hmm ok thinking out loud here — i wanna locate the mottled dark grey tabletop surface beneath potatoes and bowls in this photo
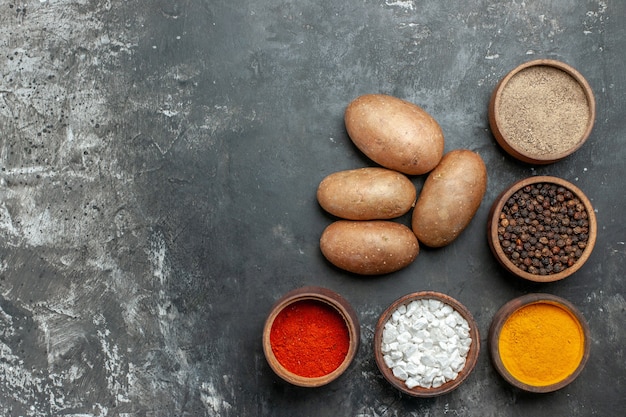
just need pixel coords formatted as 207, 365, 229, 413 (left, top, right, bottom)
0, 0, 626, 417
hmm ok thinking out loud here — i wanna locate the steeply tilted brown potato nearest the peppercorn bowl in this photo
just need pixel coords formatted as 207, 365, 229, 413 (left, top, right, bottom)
411, 149, 487, 248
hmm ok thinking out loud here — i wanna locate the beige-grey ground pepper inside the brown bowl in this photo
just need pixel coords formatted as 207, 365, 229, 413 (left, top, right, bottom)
498, 65, 591, 155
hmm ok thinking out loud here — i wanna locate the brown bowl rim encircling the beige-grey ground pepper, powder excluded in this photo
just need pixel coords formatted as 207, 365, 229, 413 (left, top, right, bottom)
488, 59, 596, 164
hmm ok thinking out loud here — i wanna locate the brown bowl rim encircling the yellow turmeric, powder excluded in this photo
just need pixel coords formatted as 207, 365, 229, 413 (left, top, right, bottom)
488, 293, 591, 393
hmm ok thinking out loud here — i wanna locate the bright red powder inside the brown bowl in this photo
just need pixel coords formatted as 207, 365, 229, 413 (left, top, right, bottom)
270, 300, 350, 378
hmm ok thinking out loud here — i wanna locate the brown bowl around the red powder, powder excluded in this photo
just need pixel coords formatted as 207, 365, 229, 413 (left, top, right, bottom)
263, 286, 361, 387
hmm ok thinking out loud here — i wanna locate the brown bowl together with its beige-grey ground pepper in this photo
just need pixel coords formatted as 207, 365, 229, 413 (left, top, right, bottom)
489, 59, 596, 164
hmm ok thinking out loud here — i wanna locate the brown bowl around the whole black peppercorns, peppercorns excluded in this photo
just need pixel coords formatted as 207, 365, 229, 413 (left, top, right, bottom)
487, 176, 597, 282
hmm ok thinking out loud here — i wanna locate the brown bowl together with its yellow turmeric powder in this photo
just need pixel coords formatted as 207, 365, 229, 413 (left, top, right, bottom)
489, 293, 591, 393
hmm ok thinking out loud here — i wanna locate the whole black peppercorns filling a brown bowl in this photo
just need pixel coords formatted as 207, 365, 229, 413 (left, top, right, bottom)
498, 183, 589, 275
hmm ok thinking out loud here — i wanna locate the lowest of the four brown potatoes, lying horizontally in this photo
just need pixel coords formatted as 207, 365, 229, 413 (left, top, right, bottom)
320, 220, 419, 275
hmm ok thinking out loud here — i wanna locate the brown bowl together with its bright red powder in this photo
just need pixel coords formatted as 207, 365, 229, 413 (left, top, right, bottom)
263, 286, 360, 387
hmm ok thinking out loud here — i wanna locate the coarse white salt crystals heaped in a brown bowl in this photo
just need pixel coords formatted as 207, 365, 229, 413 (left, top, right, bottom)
381, 299, 472, 389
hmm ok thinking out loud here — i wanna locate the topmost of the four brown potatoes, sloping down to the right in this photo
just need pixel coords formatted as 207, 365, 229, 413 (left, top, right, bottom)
344, 94, 444, 175
